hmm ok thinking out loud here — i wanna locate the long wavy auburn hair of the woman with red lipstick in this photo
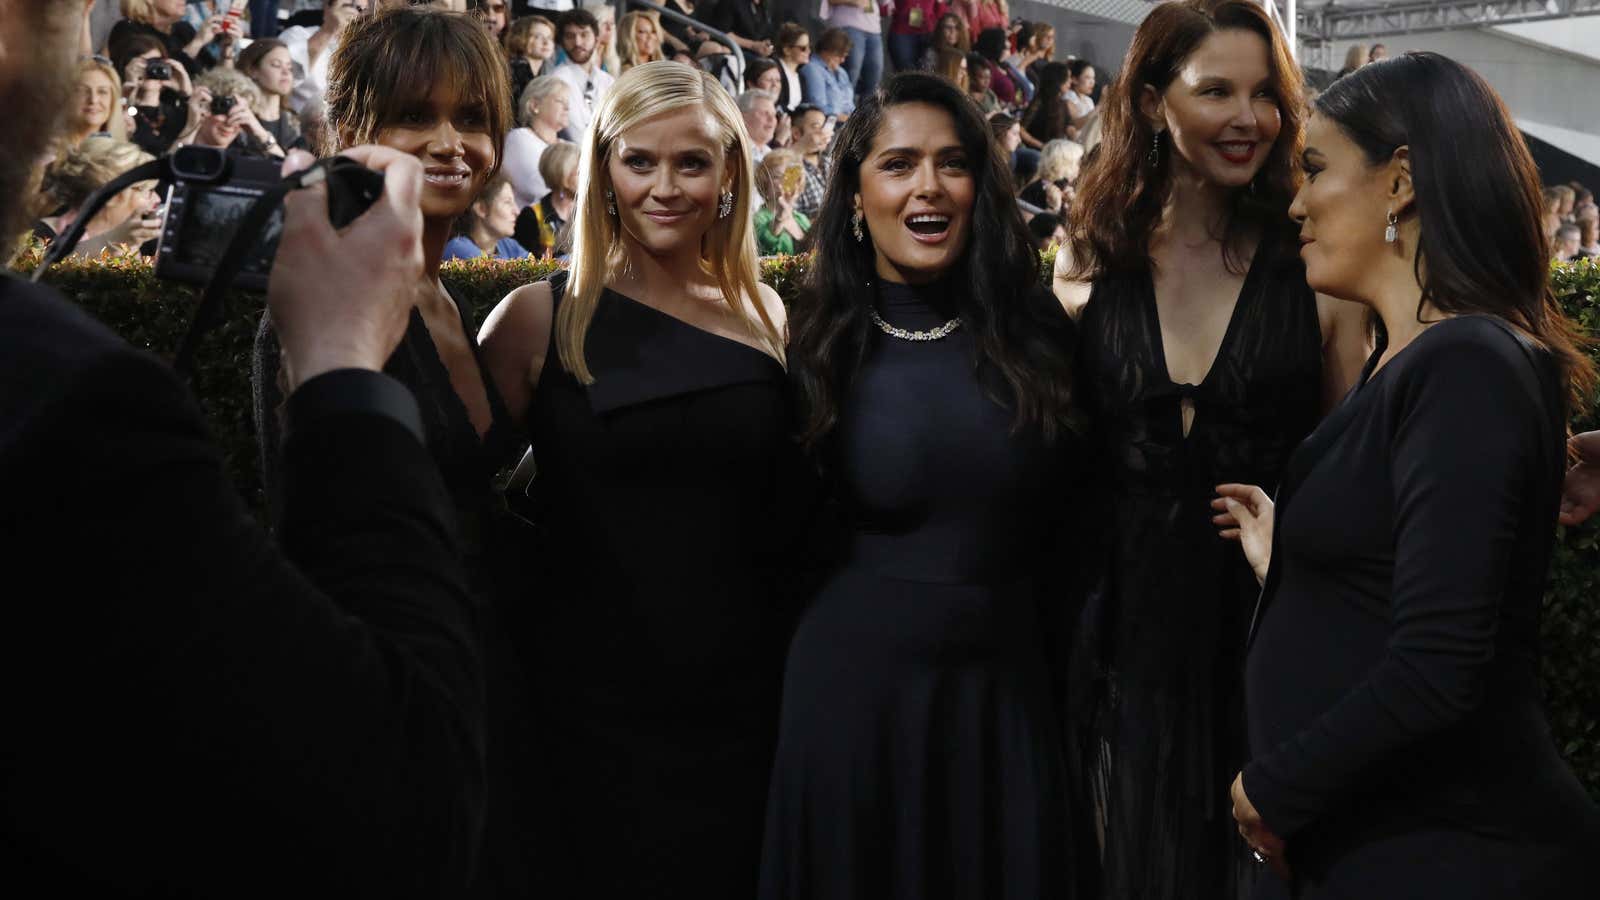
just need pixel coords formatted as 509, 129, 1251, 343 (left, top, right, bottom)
1072, 0, 1304, 282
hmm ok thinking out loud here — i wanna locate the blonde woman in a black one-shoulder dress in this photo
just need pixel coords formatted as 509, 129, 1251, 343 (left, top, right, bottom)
483, 61, 805, 900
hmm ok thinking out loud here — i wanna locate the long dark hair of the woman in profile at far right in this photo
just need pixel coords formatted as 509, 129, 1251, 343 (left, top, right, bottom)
1315, 51, 1595, 408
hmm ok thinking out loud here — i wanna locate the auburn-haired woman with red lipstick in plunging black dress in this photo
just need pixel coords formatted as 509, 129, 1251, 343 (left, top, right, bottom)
1056, 0, 1365, 900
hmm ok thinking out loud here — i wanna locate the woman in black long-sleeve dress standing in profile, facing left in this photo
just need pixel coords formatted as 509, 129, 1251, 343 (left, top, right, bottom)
1224, 53, 1600, 900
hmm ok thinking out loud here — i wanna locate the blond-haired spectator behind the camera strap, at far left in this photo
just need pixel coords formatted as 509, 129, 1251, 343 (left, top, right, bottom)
34, 136, 162, 256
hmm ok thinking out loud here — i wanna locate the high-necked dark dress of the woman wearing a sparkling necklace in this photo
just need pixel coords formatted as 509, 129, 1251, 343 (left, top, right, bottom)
760, 285, 1075, 900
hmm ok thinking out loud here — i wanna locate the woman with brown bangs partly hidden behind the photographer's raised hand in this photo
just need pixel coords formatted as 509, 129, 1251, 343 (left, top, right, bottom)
253, 5, 536, 895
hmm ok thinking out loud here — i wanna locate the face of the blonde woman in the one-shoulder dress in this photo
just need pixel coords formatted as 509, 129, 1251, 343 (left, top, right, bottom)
606, 109, 731, 256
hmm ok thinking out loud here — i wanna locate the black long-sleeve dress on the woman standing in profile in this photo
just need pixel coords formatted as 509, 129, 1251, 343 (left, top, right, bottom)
1245, 315, 1600, 900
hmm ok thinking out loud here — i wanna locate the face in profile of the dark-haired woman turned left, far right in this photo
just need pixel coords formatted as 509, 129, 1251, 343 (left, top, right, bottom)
1290, 115, 1398, 299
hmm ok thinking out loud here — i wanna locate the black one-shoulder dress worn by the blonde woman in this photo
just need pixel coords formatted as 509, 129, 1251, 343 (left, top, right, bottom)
514, 272, 803, 900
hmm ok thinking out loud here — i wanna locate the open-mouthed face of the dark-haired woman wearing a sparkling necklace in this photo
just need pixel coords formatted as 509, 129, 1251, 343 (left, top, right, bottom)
856, 102, 978, 283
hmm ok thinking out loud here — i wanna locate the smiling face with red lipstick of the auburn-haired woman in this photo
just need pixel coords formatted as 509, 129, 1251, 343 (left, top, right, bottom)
1142, 29, 1283, 187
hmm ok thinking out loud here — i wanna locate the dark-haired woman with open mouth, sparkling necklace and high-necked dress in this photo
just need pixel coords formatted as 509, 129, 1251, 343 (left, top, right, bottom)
760, 72, 1082, 900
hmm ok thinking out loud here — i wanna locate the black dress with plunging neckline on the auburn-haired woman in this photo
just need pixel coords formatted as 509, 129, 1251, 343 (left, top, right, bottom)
1074, 240, 1322, 900
